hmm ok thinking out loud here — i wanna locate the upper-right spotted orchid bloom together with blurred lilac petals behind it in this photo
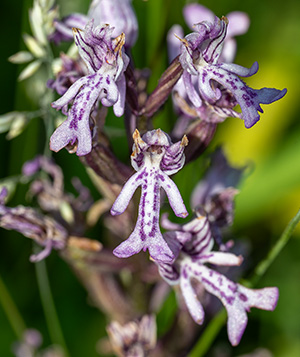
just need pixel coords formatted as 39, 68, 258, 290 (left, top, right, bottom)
168, 4, 286, 129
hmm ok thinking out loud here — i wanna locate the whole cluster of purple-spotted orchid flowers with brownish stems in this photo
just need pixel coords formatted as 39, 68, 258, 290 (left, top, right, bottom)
0, 0, 286, 357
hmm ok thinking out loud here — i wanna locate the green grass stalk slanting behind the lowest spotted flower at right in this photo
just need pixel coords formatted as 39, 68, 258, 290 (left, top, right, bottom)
188, 209, 300, 357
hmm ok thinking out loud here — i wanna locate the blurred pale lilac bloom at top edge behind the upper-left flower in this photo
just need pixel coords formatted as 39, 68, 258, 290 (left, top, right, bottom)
50, 0, 138, 48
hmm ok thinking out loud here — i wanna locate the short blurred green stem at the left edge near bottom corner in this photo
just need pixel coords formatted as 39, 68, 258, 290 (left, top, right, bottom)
0, 277, 26, 341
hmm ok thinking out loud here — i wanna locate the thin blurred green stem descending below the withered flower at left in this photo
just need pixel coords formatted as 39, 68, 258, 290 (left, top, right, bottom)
35, 254, 69, 357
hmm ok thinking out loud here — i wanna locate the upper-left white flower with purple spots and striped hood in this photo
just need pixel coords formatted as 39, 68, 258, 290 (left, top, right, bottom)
50, 20, 129, 156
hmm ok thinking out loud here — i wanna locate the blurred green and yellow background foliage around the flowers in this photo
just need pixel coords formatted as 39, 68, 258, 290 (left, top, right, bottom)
0, 0, 300, 357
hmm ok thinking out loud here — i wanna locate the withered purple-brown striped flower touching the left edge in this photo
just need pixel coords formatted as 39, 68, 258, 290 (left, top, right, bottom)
0, 189, 68, 262
